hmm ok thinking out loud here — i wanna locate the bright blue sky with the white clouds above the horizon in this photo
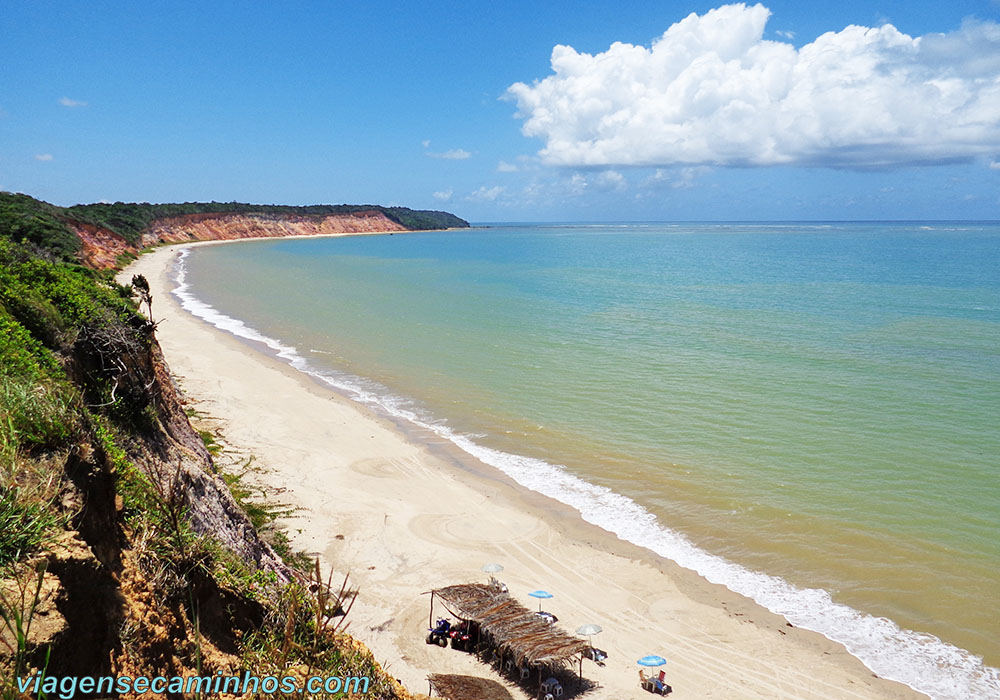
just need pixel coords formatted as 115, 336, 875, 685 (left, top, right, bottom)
0, 0, 1000, 222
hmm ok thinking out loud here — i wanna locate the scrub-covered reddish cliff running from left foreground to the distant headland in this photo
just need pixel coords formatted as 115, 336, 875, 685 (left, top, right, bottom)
0, 193, 446, 700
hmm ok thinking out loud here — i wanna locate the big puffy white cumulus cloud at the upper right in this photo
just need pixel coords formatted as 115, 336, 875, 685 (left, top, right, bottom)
507, 4, 1000, 168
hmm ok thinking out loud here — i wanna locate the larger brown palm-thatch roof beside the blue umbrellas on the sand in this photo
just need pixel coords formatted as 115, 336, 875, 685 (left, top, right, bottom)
431, 583, 589, 666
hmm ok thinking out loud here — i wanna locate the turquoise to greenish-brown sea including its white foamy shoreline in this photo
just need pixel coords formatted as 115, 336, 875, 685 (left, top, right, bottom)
182, 223, 1000, 698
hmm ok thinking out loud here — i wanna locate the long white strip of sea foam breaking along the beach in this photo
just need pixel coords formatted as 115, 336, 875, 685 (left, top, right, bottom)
173, 249, 1000, 700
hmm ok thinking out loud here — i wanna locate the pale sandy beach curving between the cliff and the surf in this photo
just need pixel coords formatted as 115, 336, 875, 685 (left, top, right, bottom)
121, 244, 925, 700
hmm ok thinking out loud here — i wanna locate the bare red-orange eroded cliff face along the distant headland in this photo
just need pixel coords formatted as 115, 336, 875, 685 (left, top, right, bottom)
69, 211, 407, 269
